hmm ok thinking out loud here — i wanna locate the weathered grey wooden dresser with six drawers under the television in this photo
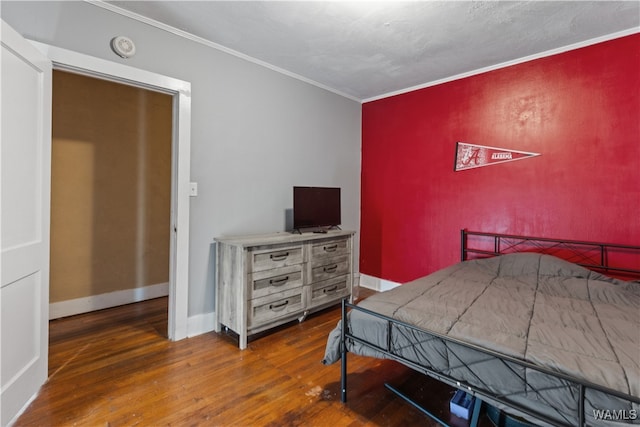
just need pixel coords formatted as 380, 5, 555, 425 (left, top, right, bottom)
215, 230, 355, 349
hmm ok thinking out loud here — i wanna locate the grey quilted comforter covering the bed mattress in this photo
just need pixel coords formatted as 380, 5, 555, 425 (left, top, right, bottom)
323, 253, 640, 425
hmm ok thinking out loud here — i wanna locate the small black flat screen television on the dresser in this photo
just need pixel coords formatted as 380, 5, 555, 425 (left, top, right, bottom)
293, 187, 341, 230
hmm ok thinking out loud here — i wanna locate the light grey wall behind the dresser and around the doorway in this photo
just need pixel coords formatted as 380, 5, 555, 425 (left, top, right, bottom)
0, 1, 361, 317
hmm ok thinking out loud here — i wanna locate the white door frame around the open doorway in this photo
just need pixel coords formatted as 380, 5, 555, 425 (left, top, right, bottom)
29, 40, 191, 341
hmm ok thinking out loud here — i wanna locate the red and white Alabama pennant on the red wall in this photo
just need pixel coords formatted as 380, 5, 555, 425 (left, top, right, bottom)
454, 142, 540, 172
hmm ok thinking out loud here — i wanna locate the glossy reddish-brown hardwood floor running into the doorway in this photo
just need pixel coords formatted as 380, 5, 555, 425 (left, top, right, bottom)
16, 292, 490, 427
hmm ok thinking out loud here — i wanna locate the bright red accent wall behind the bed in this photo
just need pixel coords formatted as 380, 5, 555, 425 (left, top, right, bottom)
360, 34, 640, 282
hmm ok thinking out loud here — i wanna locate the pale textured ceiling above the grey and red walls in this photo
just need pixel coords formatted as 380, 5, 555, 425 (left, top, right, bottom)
102, 1, 640, 101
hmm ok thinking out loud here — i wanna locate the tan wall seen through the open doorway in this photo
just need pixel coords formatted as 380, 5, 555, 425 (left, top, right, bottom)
50, 71, 172, 303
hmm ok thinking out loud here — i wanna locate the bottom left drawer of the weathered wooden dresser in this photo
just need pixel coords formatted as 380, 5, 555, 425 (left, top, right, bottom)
248, 288, 304, 328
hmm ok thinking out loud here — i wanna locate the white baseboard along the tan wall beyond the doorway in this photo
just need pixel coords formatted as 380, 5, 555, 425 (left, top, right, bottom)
49, 282, 169, 320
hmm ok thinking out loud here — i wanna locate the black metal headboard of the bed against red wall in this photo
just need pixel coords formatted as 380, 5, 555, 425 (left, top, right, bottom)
460, 229, 640, 280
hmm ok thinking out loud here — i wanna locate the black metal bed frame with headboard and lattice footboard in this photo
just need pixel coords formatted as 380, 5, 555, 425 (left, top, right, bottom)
340, 230, 640, 426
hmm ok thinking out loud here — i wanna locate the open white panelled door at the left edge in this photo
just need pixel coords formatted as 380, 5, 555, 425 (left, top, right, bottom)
0, 21, 51, 426
